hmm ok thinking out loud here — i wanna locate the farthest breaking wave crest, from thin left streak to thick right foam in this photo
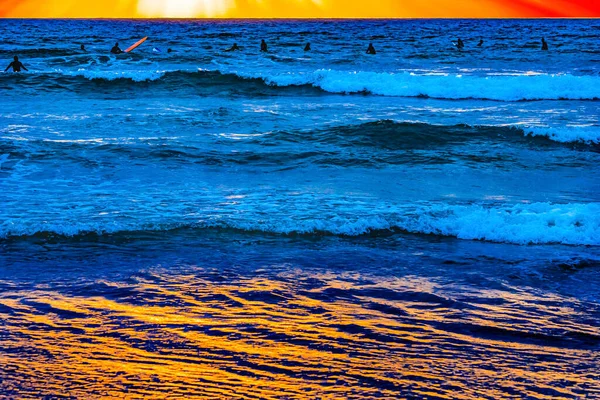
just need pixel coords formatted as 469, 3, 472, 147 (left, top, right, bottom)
4, 69, 600, 101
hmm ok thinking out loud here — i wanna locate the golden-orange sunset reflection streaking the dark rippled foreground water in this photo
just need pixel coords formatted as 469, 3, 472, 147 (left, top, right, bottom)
0, 270, 600, 399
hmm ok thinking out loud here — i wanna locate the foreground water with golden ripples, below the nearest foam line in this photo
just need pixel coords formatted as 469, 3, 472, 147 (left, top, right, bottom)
0, 231, 600, 399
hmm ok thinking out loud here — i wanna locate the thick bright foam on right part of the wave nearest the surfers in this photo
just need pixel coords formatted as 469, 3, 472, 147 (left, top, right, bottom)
236, 69, 600, 101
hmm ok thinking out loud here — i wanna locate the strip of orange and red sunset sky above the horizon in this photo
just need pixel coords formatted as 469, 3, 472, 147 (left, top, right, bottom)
0, 0, 600, 18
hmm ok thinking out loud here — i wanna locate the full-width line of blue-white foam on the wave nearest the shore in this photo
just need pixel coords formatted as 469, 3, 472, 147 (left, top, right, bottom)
0, 203, 600, 246
